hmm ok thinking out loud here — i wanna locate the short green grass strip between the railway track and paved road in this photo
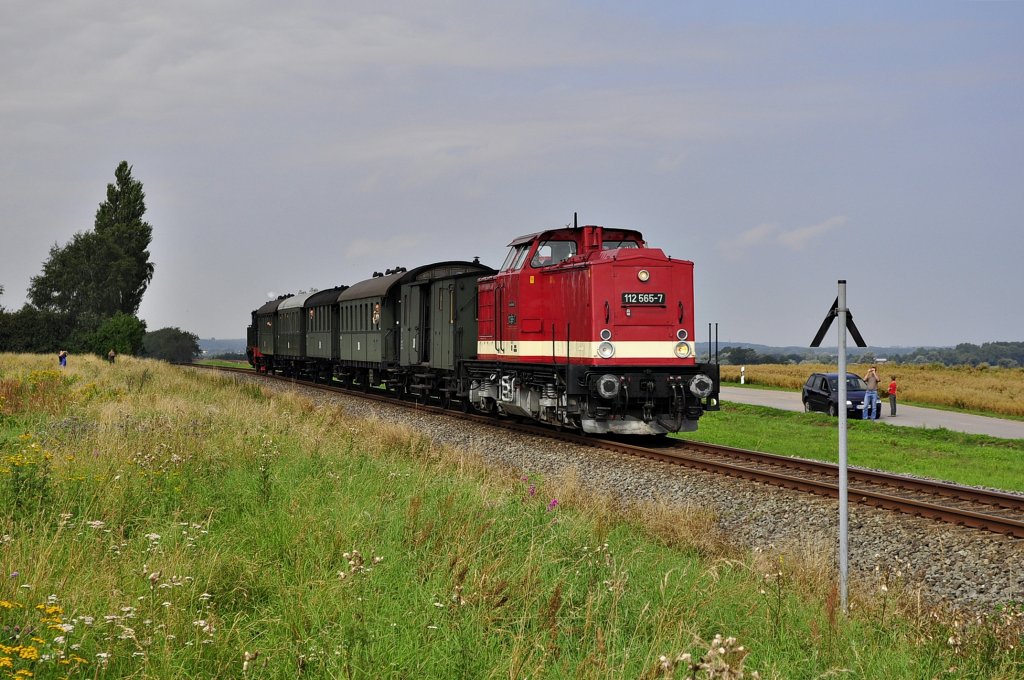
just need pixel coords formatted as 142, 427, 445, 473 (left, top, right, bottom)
679, 402, 1024, 493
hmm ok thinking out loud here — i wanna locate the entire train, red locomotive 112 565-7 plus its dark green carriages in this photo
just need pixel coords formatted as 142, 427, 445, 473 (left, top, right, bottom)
248, 226, 719, 434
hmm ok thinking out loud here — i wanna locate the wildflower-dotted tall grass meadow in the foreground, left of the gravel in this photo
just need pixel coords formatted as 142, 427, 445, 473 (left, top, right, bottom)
0, 355, 1024, 678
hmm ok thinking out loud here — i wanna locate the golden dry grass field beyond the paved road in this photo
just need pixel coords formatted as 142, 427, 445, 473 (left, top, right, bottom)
722, 364, 1024, 417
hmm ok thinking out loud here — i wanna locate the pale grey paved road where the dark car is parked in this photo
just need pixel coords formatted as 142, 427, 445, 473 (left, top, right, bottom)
722, 387, 1024, 439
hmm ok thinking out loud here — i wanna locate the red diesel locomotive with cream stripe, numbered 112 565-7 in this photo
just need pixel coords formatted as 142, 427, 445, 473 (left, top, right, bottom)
464, 226, 719, 434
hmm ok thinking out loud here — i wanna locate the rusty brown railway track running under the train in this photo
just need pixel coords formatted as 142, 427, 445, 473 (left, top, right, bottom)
192, 367, 1024, 539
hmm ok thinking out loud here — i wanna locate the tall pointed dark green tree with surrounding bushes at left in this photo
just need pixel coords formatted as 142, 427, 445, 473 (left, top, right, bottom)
0, 161, 200, 362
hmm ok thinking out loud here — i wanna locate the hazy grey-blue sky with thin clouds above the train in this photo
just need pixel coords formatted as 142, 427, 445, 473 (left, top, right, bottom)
0, 0, 1024, 347
